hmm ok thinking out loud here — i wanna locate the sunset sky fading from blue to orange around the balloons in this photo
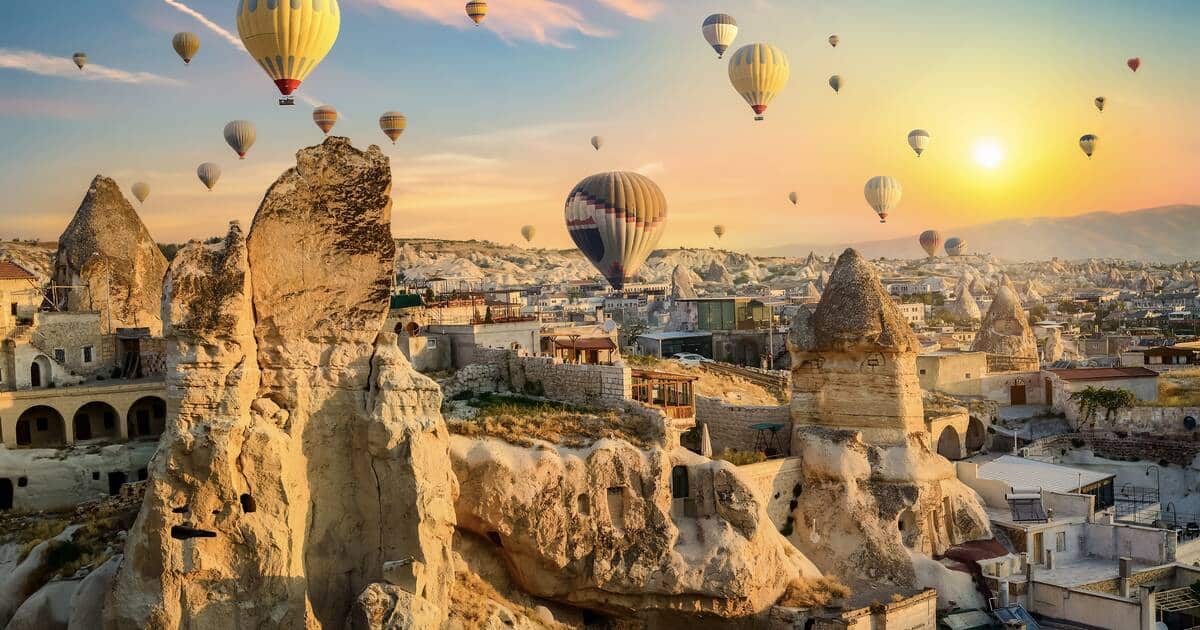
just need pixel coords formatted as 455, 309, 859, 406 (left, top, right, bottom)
0, 0, 1200, 251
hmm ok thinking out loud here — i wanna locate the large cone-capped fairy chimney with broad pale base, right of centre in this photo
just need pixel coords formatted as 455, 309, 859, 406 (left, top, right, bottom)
788, 250, 990, 589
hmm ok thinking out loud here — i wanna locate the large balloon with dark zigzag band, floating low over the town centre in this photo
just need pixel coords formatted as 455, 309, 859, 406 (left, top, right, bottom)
564, 172, 667, 289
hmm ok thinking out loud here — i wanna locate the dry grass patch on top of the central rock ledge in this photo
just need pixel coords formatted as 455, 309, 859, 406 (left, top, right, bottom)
446, 394, 653, 449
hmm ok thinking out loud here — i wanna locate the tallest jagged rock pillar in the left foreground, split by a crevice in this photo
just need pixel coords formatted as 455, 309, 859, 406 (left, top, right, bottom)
106, 137, 457, 630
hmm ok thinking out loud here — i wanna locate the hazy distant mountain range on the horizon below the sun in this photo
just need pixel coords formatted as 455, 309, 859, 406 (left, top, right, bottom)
755, 205, 1200, 263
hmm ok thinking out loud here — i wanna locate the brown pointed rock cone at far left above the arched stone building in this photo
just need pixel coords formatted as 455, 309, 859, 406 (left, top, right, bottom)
53, 175, 167, 336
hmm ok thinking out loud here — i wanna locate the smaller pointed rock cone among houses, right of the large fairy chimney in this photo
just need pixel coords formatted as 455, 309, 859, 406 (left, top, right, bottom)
971, 277, 1038, 372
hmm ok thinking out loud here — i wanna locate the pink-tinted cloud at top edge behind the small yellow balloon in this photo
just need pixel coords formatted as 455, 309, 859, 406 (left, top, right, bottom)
358, 0, 614, 48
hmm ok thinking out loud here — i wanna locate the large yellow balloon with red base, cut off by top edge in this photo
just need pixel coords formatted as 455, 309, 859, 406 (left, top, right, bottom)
238, 0, 342, 104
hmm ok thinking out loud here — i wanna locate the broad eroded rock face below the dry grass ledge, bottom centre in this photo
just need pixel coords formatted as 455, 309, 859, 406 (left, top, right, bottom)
450, 436, 820, 617
